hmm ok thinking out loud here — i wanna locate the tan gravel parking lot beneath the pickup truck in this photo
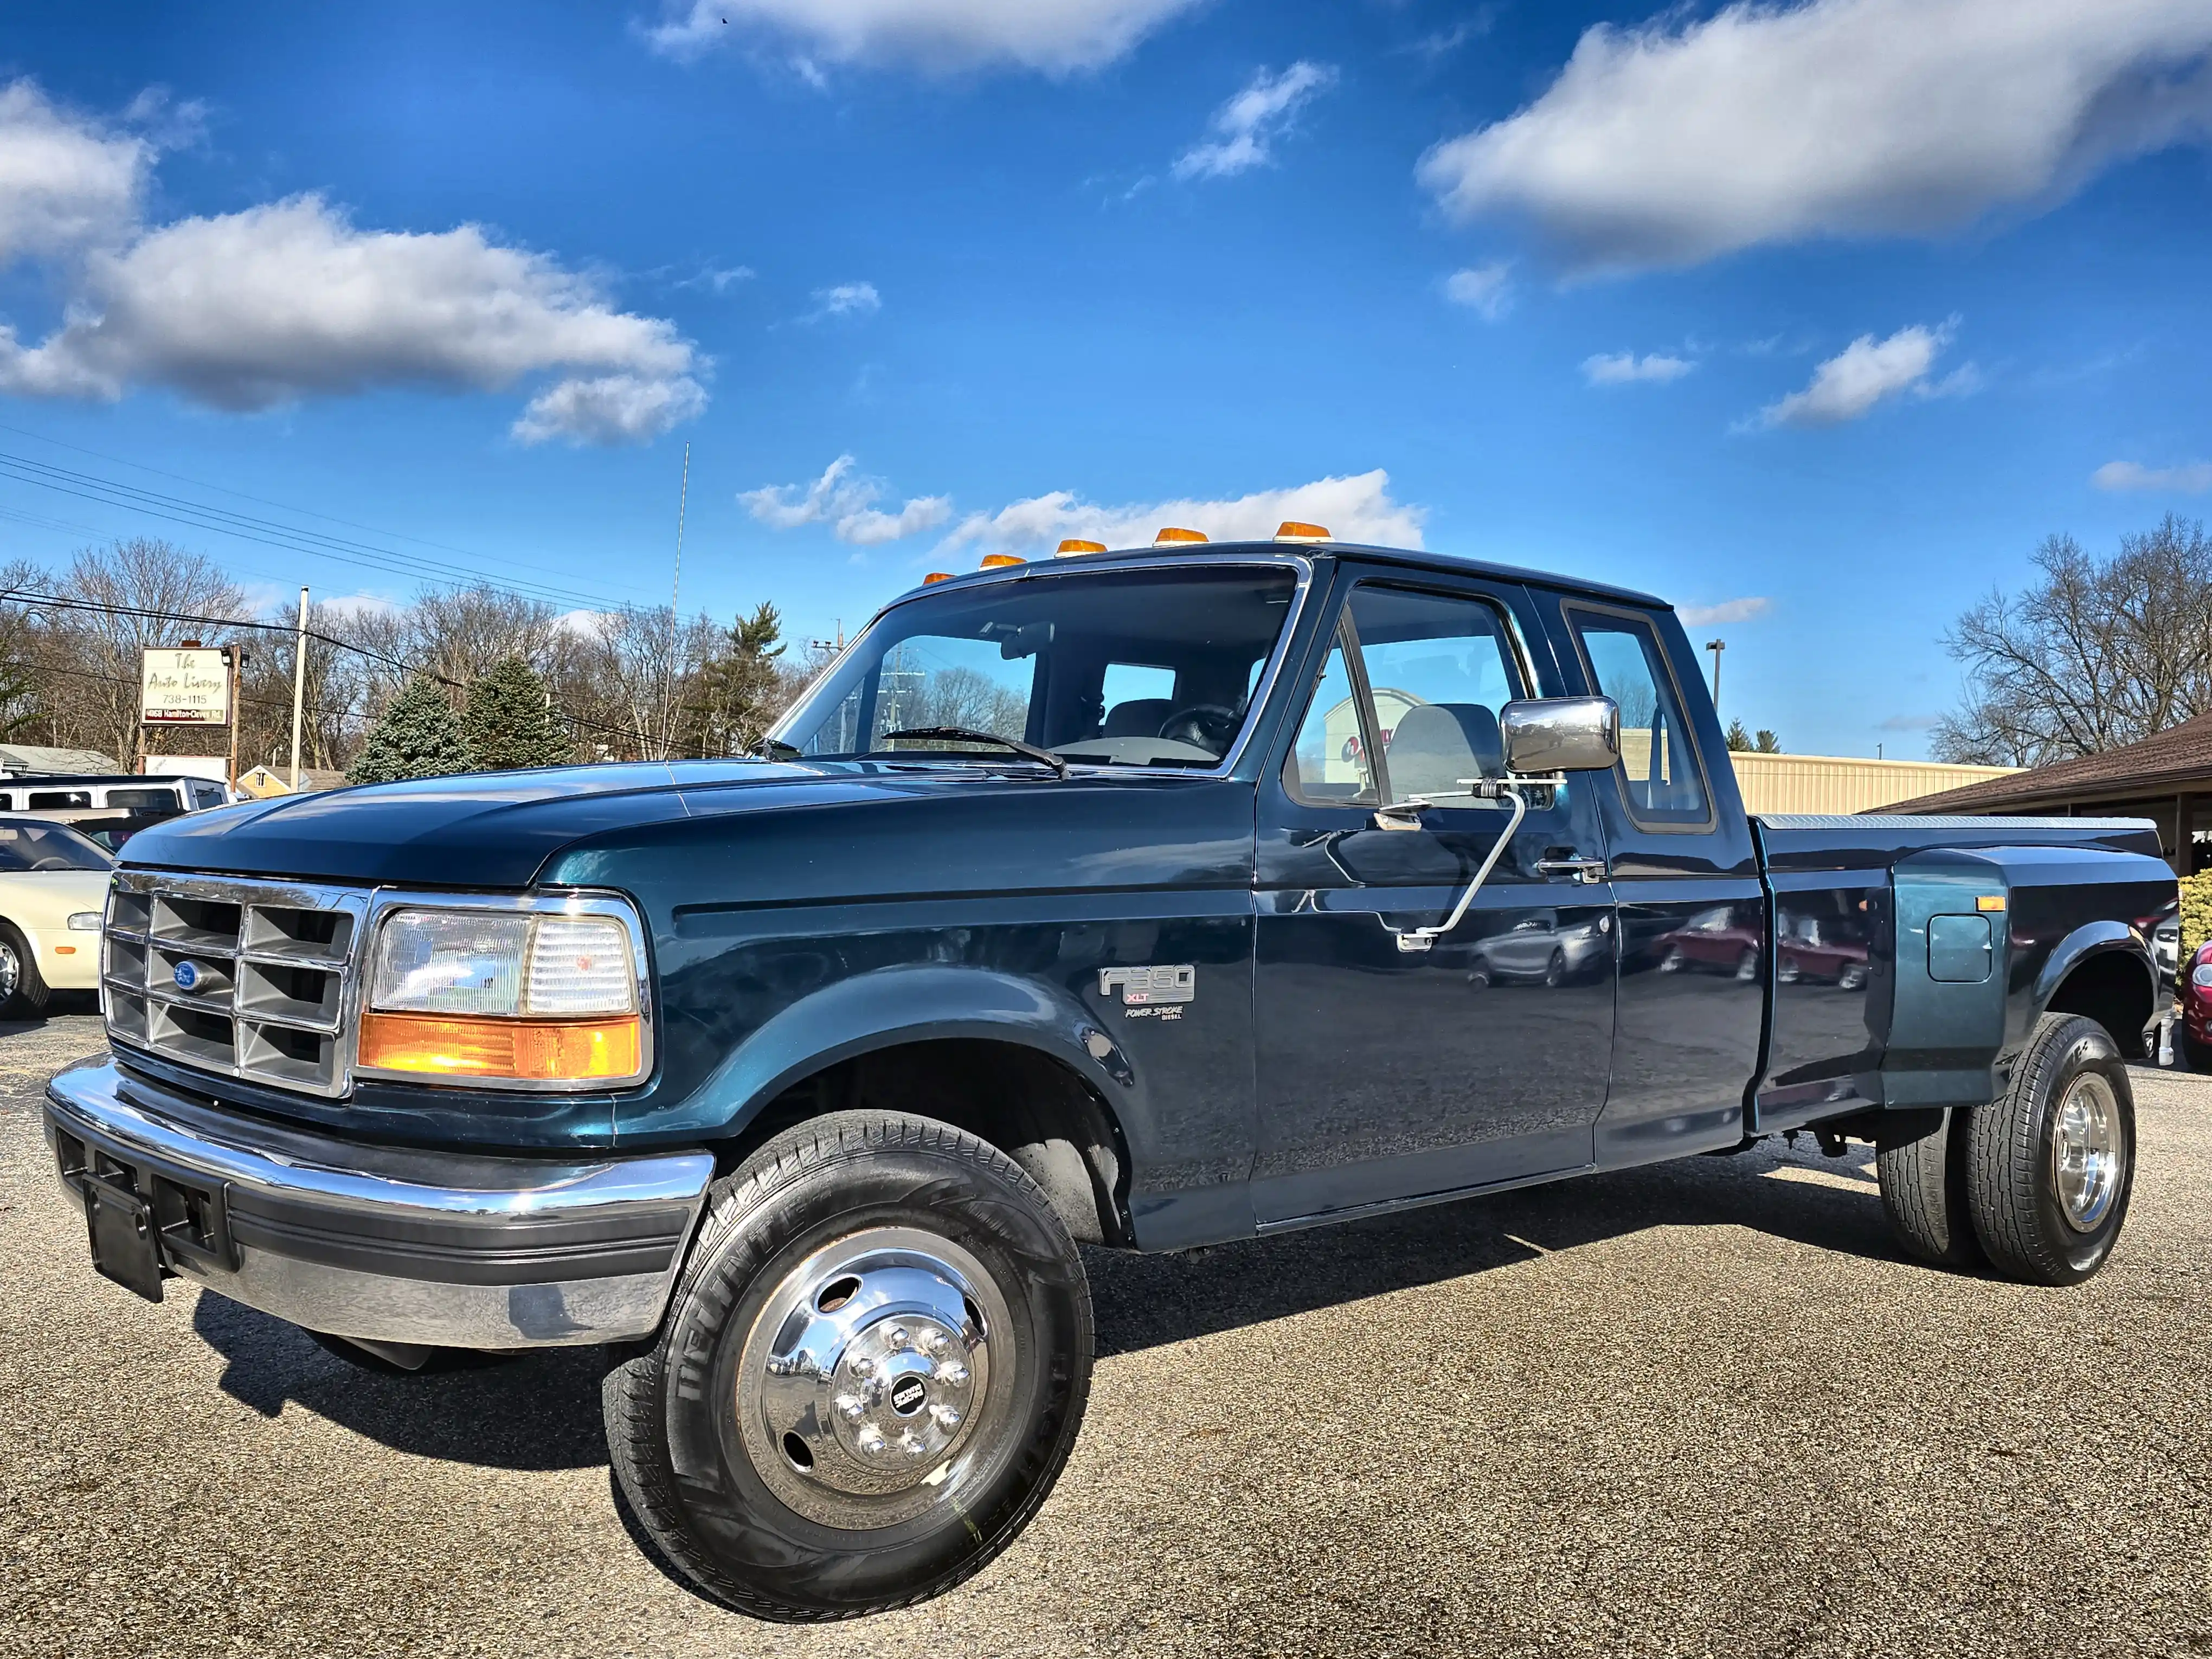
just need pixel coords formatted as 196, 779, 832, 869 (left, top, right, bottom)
0, 1013, 2212, 1659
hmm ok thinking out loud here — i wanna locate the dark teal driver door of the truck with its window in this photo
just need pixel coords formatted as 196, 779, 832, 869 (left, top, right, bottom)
1252, 571, 1615, 1225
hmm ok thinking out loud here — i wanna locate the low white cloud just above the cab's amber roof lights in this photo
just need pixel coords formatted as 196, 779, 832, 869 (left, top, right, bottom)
944, 467, 1427, 553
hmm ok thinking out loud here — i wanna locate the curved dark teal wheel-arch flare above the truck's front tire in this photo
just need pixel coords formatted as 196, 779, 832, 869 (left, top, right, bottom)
699, 962, 1143, 1133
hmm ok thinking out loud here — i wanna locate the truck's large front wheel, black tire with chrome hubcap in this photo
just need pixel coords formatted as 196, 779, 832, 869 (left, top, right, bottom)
604, 1113, 1093, 1622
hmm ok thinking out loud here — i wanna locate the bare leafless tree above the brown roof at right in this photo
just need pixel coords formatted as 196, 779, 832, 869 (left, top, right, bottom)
1931, 513, 2212, 766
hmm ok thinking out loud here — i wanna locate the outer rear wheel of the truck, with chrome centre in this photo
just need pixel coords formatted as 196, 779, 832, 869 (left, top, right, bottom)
1966, 1013, 2134, 1285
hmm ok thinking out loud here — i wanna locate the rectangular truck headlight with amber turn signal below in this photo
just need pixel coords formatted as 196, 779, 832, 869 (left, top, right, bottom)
358, 905, 646, 1084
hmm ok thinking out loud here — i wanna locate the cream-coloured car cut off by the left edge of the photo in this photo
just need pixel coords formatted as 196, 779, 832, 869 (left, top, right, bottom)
0, 814, 115, 1020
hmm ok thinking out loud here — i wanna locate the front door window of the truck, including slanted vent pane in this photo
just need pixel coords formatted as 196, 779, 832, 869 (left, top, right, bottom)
1285, 584, 1522, 803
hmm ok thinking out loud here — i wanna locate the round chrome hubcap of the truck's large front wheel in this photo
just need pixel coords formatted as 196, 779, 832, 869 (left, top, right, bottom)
737, 1227, 1013, 1528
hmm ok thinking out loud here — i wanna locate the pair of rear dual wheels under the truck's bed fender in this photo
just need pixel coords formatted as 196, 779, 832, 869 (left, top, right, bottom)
1876, 1013, 2134, 1285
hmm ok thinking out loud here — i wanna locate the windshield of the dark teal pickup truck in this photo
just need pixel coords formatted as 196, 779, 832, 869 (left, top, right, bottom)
770, 564, 1298, 770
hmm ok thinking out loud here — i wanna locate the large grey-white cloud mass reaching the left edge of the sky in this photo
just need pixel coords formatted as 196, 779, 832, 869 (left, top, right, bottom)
0, 82, 708, 442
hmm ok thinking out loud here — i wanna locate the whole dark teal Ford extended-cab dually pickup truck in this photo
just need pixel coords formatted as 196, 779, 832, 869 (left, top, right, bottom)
47, 535, 2175, 1619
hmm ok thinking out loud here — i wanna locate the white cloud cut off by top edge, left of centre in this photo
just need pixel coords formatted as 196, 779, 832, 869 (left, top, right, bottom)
648, 0, 1201, 80
